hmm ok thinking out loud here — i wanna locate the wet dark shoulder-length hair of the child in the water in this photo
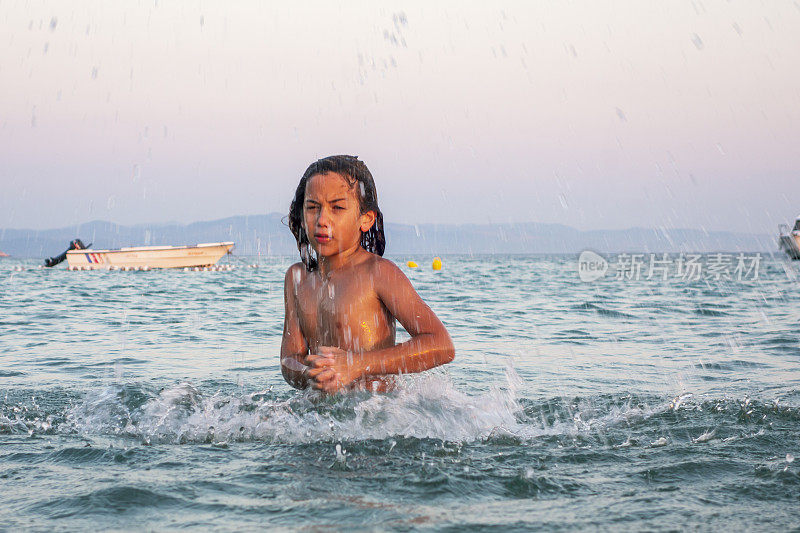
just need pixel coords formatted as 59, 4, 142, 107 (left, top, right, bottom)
289, 155, 386, 272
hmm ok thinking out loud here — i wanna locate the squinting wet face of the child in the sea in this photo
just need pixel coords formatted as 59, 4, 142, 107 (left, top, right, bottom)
303, 172, 375, 257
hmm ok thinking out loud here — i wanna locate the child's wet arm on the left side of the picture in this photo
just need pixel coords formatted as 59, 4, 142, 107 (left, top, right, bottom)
281, 263, 308, 389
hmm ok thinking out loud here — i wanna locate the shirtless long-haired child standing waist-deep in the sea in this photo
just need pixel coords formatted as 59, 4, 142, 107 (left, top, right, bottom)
281, 156, 455, 393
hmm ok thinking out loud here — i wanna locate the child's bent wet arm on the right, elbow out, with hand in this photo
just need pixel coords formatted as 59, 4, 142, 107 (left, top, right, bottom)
307, 259, 455, 392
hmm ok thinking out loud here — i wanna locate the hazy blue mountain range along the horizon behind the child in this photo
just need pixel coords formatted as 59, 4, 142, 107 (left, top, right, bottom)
0, 213, 777, 258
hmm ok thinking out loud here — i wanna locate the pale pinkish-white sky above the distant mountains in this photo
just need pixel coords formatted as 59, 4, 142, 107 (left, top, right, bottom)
0, 0, 800, 233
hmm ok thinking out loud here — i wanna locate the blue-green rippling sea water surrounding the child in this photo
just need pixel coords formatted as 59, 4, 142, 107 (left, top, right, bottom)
0, 256, 800, 531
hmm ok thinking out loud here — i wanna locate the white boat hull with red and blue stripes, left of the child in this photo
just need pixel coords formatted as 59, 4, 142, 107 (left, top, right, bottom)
66, 242, 234, 270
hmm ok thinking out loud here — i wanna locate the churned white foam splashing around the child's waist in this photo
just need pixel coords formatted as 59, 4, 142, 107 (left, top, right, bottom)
65, 368, 667, 443
